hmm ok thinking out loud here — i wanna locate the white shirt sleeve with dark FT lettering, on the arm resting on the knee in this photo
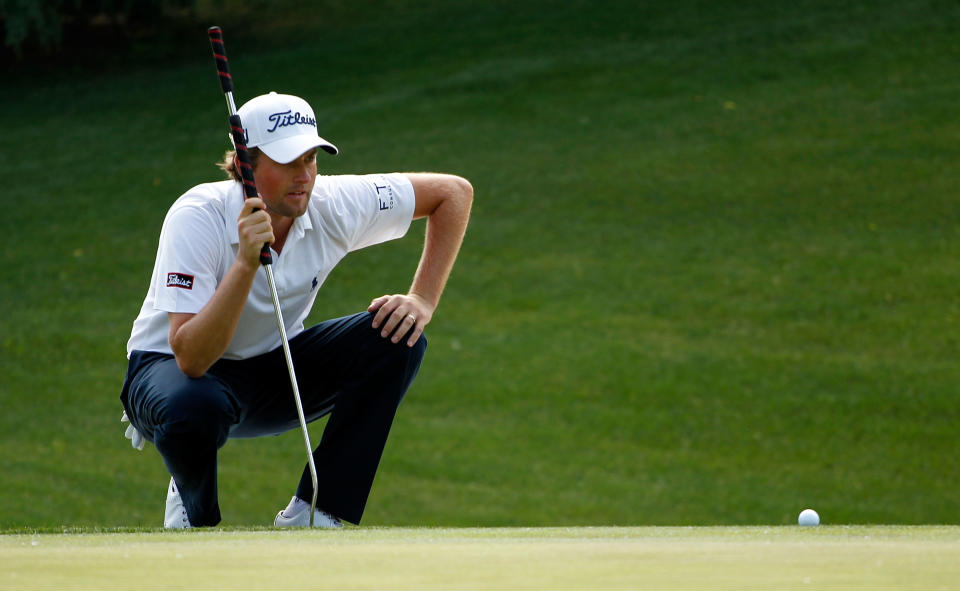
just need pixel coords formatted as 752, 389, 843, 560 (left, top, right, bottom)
335, 173, 416, 251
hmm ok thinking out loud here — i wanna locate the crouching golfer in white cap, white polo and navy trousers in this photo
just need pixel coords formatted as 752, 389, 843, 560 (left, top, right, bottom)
121, 92, 473, 528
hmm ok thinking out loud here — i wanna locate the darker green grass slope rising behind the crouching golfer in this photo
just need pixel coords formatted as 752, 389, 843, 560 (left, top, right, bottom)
0, 0, 960, 530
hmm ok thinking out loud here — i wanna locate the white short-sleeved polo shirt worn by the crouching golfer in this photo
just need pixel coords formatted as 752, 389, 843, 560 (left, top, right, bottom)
127, 174, 415, 359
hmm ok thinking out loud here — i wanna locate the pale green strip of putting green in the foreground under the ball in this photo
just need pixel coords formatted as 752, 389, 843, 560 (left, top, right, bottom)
0, 526, 960, 591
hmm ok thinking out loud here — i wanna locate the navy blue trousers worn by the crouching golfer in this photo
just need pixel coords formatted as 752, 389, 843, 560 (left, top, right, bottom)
120, 312, 427, 526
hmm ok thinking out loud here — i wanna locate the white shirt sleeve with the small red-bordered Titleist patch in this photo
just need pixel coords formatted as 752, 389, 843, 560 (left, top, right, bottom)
153, 205, 225, 314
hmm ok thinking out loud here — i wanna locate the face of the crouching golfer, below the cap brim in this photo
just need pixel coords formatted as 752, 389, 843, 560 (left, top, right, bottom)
253, 148, 317, 218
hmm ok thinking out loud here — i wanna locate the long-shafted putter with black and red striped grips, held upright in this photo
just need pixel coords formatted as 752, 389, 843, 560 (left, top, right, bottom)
207, 27, 318, 528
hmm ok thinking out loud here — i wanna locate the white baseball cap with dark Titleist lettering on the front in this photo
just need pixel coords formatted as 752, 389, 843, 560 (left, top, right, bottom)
237, 92, 337, 164
